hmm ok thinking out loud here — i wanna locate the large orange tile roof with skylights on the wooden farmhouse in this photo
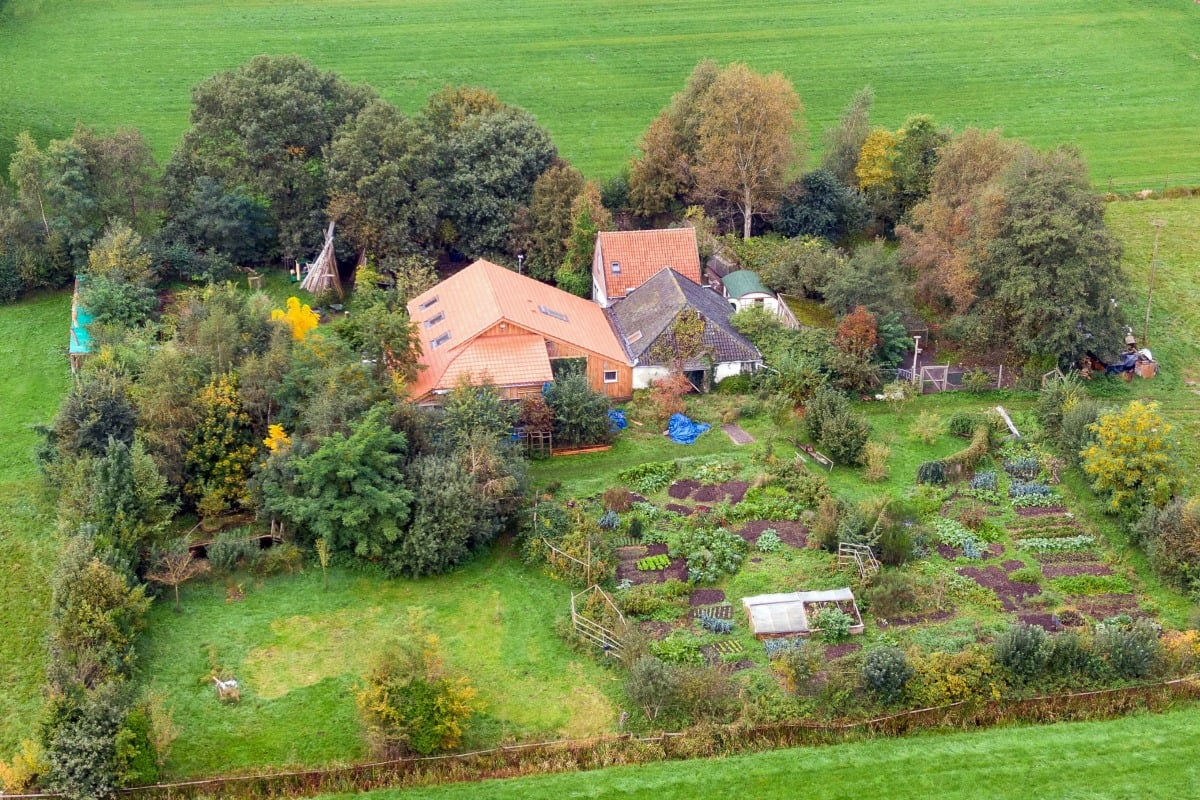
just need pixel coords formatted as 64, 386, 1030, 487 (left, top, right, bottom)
408, 259, 629, 398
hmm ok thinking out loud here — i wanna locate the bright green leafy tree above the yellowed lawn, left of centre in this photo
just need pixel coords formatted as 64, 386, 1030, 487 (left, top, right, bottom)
263, 404, 413, 561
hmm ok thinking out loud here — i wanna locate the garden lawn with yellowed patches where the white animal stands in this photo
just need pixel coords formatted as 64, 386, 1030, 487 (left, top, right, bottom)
143, 547, 619, 777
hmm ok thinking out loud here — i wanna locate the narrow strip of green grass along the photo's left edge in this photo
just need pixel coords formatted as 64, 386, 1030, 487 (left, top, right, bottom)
0, 293, 71, 758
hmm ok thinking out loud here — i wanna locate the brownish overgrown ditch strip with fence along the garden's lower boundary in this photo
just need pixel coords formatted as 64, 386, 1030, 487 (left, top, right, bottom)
2, 674, 1200, 800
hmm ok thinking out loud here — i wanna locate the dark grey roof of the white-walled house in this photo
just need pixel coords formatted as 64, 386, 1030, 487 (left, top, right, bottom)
607, 270, 762, 369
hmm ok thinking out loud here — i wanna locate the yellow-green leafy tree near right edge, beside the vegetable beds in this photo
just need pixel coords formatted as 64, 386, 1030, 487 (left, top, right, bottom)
1081, 401, 1180, 512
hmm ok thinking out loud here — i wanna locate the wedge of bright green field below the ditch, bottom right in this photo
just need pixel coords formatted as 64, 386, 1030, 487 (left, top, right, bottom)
324, 709, 1200, 800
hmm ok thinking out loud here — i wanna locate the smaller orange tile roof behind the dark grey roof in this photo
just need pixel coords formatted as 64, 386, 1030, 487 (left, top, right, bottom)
598, 228, 700, 300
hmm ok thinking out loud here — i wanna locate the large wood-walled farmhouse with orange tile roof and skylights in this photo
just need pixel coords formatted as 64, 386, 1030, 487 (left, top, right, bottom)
408, 259, 632, 403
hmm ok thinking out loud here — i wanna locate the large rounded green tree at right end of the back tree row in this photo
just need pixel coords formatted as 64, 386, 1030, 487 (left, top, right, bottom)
979, 149, 1127, 365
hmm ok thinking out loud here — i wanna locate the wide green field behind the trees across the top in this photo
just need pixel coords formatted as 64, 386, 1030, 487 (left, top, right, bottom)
0, 0, 1200, 190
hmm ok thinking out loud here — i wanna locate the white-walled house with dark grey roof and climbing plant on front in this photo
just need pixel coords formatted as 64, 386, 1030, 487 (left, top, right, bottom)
608, 269, 762, 389
